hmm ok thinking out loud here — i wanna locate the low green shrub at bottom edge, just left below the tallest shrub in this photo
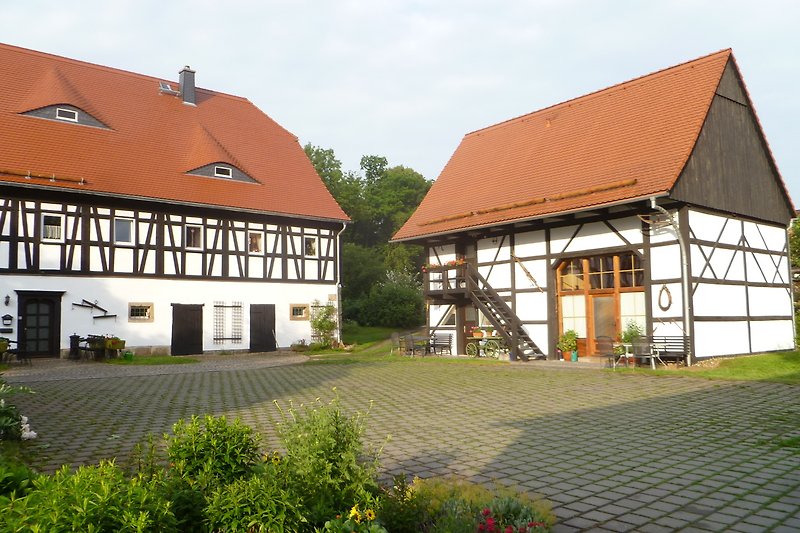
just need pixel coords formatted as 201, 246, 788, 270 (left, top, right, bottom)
206, 475, 305, 533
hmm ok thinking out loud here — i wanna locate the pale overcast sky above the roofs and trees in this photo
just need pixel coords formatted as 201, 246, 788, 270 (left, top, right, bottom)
6, 0, 800, 206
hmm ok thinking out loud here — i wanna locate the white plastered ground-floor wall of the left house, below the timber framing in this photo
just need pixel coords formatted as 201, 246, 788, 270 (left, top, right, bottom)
0, 275, 336, 350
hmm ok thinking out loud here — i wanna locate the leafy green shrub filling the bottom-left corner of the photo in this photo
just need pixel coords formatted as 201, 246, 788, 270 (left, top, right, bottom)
0, 461, 175, 533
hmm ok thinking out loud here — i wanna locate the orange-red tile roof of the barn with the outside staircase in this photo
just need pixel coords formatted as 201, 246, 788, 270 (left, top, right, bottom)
394, 50, 732, 240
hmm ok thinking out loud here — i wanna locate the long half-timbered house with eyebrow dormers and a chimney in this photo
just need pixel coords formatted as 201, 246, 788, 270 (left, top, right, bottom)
0, 45, 347, 356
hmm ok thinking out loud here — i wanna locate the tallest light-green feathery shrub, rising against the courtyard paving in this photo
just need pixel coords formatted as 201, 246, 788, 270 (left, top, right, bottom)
276, 392, 377, 526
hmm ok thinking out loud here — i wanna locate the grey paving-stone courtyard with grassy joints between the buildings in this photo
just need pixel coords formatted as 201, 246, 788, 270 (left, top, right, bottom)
4, 354, 800, 532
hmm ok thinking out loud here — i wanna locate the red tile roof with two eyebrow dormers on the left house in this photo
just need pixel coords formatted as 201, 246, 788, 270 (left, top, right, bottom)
0, 44, 347, 221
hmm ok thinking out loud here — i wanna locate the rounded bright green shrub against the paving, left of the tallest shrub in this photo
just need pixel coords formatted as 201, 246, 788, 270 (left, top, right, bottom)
164, 415, 259, 490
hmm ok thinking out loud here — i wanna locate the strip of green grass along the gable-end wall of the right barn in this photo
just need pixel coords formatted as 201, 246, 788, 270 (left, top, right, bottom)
618, 351, 800, 385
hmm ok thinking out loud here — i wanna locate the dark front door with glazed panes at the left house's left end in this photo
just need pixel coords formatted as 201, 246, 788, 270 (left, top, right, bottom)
18, 292, 61, 357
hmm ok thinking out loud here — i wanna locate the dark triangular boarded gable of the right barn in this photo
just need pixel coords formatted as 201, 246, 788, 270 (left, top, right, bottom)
670, 60, 794, 225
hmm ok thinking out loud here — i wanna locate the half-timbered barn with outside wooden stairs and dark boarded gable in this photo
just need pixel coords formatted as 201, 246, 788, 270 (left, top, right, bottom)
394, 50, 794, 361
